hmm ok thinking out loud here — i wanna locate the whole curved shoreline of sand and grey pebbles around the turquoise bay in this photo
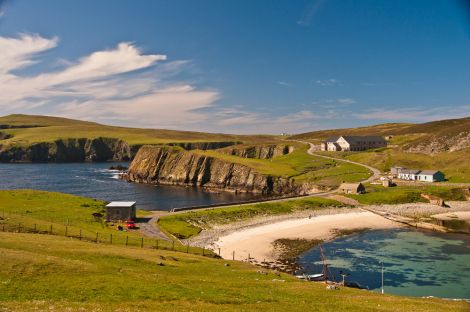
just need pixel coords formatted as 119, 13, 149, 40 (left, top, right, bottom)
188, 202, 470, 269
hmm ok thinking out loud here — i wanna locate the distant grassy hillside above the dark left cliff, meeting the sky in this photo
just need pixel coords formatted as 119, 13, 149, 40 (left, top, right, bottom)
0, 115, 272, 146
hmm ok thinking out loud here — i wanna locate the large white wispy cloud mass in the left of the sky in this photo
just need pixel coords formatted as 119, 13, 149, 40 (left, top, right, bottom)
0, 34, 219, 127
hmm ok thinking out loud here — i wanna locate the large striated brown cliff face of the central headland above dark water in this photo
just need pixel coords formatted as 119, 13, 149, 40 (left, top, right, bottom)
126, 146, 308, 195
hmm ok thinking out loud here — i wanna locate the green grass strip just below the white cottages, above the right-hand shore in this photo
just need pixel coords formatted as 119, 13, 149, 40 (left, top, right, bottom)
346, 184, 465, 205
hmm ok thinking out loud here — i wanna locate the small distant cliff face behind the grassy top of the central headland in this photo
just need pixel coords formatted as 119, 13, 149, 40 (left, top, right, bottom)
220, 144, 294, 159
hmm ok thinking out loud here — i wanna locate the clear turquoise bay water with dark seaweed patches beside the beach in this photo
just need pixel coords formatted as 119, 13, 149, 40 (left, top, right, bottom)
299, 229, 470, 299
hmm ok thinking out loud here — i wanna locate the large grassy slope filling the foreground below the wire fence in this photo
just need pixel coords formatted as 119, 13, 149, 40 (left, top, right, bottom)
0, 233, 469, 311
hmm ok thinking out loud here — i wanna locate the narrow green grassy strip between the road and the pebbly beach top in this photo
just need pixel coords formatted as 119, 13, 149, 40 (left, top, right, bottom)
158, 198, 344, 238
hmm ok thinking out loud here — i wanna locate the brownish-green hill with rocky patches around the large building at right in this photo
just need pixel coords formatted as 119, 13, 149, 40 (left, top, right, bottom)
291, 117, 470, 182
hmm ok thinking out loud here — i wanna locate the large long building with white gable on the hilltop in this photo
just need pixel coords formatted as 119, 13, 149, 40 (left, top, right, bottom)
321, 136, 387, 152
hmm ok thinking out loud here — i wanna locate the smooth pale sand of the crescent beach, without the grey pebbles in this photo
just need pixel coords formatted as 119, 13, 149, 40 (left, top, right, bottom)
211, 209, 401, 262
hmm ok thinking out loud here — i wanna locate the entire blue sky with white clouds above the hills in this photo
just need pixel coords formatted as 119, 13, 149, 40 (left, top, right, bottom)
0, 0, 470, 134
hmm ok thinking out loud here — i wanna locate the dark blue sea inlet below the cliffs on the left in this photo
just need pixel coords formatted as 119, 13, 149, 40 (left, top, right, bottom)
0, 162, 259, 210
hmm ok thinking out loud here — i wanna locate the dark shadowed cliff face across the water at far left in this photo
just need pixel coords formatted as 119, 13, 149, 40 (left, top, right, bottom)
0, 138, 140, 162
